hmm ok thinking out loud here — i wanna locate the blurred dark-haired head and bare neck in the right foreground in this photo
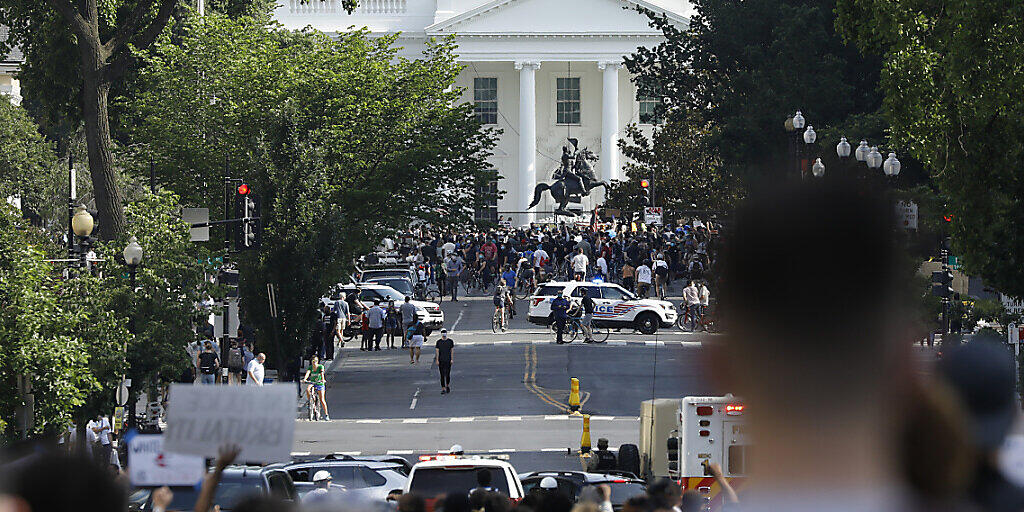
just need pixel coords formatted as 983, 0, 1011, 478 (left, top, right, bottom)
712, 181, 910, 490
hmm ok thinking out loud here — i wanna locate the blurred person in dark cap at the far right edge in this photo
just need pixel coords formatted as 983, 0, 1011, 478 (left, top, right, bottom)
939, 335, 1024, 511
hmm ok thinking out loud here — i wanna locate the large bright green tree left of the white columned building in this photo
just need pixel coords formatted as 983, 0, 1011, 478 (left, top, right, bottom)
125, 15, 495, 372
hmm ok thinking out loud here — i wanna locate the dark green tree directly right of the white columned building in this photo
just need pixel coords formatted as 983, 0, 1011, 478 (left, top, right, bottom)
626, 0, 881, 190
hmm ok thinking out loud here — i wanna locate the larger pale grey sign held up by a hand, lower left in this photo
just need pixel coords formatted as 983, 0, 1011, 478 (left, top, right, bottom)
164, 384, 296, 462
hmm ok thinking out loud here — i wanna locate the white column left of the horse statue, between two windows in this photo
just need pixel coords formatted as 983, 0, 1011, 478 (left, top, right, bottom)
515, 61, 541, 223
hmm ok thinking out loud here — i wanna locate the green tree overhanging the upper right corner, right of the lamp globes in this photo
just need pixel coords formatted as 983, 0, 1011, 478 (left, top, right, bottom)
837, 0, 1024, 297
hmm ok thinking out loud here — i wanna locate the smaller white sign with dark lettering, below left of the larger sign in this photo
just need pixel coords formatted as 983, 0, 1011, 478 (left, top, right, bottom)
128, 434, 206, 487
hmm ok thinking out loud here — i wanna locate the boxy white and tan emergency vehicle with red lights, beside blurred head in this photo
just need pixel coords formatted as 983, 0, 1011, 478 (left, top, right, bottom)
639, 394, 750, 510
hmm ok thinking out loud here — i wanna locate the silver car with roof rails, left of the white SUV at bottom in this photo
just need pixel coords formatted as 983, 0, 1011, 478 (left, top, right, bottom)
282, 457, 409, 502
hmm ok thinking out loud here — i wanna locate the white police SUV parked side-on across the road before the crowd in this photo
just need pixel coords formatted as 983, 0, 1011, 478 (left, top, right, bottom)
528, 281, 677, 334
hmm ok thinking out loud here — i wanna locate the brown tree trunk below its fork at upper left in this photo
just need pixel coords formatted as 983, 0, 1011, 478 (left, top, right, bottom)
79, 41, 125, 240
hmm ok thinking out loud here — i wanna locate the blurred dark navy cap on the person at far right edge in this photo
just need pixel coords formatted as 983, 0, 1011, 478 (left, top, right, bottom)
939, 337, 1017, 450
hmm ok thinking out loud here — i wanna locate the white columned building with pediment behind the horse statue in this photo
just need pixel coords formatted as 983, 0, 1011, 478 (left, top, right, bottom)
274, 0, 689, 223
